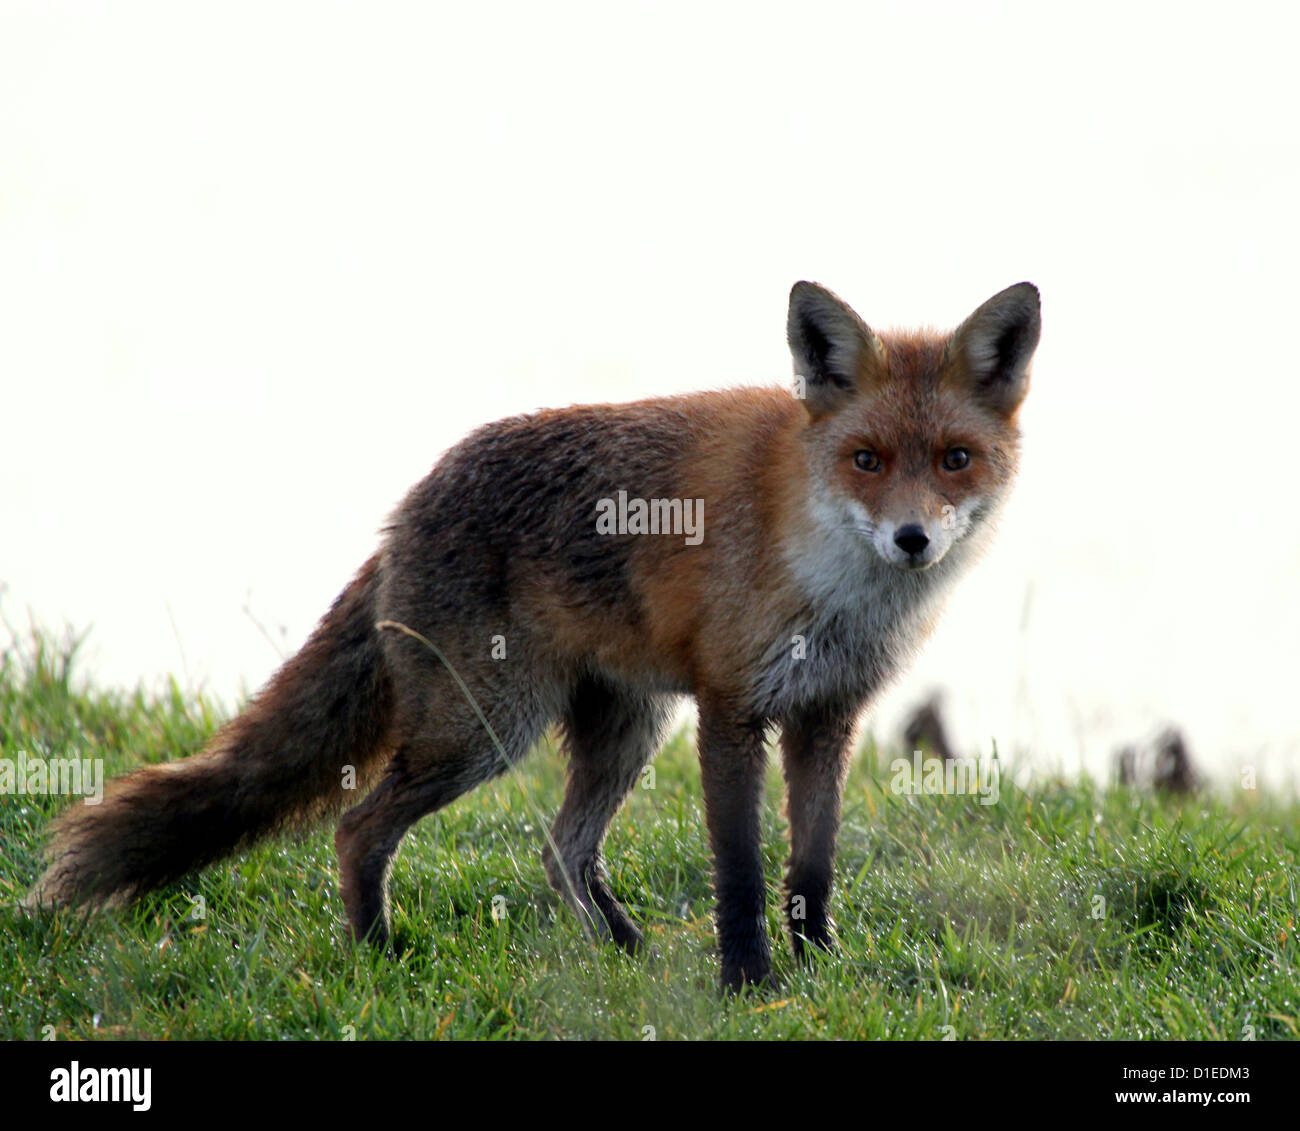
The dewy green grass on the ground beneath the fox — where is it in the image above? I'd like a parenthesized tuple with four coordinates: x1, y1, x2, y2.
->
(0, 634, 1300, 1040)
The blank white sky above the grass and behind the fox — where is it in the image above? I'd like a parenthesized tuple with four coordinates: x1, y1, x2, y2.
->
(0, 0, 1300, 788)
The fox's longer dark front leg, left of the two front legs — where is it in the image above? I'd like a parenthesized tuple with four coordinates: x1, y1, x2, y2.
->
(699, 702, 772, 991)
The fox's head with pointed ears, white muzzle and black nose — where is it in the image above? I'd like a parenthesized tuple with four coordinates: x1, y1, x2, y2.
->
(788, 282, 1040, 569)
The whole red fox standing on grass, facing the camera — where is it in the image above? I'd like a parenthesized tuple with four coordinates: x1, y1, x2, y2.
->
(27, 282, 1040, 989)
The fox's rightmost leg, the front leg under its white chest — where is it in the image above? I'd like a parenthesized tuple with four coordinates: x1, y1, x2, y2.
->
(781, 710, 854, 957)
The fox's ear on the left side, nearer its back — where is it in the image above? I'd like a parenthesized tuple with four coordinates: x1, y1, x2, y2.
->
(785, 282, 883, 416)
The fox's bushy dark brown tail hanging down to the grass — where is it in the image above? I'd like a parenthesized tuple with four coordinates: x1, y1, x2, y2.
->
(25, 555, 391, 906)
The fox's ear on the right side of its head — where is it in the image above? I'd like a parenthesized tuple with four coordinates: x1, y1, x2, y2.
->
(948, 283, 1043, 416)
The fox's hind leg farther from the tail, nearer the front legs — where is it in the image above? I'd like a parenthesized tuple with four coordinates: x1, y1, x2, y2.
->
(543, 677, 673, 953)
